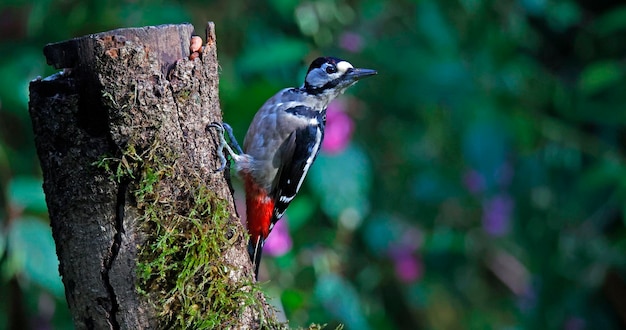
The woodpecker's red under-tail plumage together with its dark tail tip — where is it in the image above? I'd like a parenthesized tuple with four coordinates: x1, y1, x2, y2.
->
(243, 174, 274, 278)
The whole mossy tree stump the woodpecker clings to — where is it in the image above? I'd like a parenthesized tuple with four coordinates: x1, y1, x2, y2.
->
(29, 23, 274, 329)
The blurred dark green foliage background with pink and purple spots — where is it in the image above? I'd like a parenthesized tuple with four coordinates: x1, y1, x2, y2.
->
(0, 0, 626, 330)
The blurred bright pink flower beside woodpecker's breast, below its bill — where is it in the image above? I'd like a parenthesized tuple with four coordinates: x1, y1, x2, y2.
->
(322, 101, 354, 154)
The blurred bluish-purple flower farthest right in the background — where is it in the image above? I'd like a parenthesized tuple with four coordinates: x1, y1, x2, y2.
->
(483, 194, 514, 236)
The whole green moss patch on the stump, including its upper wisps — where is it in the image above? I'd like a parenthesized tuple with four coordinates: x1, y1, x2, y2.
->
(95, 141, 266, 329)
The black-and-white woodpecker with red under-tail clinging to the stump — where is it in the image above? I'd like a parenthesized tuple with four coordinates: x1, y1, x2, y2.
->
(209, 57, 377, 277)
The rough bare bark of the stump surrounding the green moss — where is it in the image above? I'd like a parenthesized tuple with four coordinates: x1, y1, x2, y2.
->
(29, 23, 267, 329)
